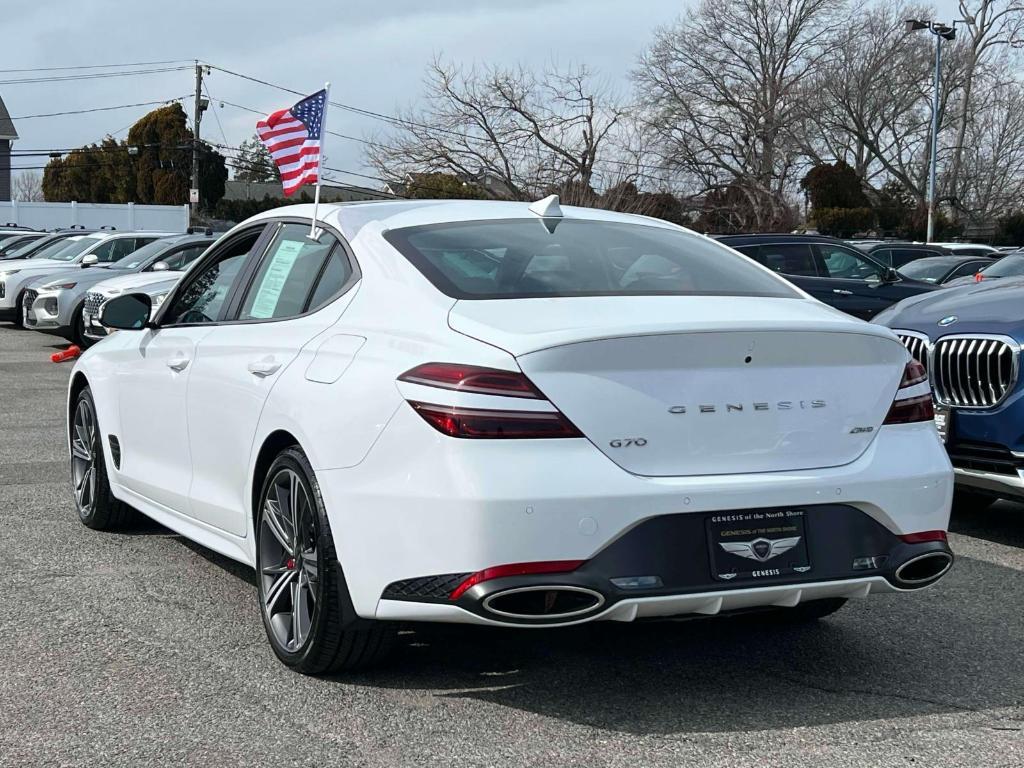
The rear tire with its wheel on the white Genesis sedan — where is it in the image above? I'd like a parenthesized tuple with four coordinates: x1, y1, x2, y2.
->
(256, 447, 395, 675)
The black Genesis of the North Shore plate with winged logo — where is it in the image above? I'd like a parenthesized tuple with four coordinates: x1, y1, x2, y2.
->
(705, 509, 812, 583)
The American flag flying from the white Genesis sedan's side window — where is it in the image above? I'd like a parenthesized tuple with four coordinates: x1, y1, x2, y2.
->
(256, 89, 327, 197)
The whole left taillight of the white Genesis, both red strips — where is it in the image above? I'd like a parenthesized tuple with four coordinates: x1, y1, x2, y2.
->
(398, 362, 583, 439)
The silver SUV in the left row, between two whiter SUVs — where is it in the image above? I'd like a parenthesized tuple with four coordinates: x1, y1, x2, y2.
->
(23, 234, 214, 345)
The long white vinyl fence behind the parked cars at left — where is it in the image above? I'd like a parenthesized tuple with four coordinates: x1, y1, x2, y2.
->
(0, 201, 188, 232)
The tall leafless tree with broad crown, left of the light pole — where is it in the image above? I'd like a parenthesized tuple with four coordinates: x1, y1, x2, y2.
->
(635, 0, 842, 228)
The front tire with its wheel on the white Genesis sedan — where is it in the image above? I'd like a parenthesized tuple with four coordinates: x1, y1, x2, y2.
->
(68, 387, 135, 530)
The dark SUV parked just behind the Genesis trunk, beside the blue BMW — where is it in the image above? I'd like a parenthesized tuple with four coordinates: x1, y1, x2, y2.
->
(718, 234, 936, 319)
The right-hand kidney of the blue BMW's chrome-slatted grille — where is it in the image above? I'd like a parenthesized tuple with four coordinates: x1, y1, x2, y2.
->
(933, 335, 1020, 409)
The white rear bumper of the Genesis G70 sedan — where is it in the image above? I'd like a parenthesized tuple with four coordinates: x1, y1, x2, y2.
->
(312, 408, 953, 624)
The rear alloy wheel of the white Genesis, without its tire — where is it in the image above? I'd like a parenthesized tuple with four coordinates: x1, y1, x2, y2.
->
(259, 468, 319, 653)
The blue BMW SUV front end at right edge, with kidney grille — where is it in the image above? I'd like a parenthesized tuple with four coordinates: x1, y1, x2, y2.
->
(874, 279, 1024, 508)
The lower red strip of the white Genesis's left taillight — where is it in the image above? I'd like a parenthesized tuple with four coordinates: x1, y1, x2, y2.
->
(409, 400, 583, 439)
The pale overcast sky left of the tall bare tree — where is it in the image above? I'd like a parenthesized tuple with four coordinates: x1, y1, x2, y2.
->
(0, 0, 686, 184)
